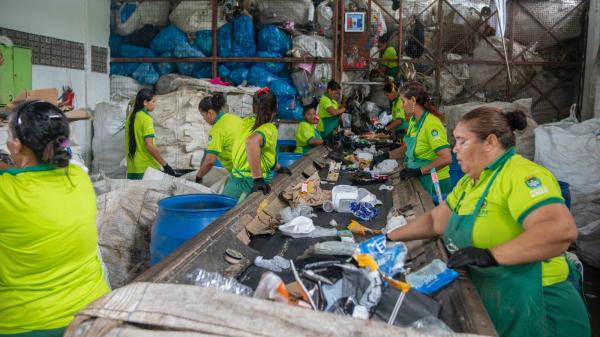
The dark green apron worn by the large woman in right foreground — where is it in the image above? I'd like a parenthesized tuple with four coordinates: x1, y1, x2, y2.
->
(443, 158, 547, 337)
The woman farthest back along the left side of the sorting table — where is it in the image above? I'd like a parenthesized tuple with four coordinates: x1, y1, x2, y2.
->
(317, 80, 346, 139)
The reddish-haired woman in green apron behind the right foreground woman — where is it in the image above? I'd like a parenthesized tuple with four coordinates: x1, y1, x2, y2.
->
(375, 82, 452, 195)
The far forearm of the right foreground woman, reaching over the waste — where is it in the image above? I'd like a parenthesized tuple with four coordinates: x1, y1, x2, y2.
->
(387, 202, 451, 241)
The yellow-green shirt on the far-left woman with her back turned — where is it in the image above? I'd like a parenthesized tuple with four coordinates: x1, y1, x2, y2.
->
(0, 164, 110, 334)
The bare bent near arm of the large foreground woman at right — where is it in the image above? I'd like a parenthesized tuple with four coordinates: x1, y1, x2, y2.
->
(491, 203, 577, 265)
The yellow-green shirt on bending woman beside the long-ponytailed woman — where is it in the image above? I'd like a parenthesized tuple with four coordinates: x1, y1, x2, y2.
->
(206, 111, 242, 172)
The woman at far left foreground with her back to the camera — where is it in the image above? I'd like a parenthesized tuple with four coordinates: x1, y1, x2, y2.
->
(0, 101, 110, 337)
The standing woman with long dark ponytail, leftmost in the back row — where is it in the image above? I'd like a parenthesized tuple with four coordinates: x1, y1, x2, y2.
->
(125, 88, 175, 180)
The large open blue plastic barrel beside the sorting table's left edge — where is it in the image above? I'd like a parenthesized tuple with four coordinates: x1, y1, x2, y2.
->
(150, 194, 237, 265)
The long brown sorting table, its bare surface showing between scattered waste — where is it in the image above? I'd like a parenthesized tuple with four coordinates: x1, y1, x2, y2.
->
(136, 146, 497, 336)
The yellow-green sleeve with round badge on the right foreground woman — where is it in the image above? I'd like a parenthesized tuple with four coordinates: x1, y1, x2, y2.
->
(508, 164, 565, 224)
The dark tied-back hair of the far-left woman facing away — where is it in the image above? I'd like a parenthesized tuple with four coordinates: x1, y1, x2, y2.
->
(10, 101, 71, 167)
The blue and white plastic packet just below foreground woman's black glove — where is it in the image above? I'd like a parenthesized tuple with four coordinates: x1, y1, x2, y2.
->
(406, 259, 458, 295)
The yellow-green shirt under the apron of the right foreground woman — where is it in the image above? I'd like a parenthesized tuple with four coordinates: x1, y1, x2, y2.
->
(446, 148, 569, 286)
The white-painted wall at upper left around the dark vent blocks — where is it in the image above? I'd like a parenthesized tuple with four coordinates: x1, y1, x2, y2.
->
(0, 0, 110, 162)
